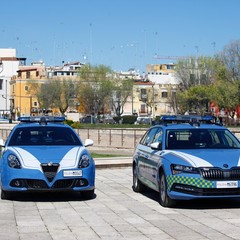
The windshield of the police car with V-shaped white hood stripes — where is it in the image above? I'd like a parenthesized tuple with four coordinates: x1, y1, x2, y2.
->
(8, 126, 82, 146)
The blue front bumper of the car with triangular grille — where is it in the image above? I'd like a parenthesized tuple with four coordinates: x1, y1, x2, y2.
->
(1, 167, 95, 192)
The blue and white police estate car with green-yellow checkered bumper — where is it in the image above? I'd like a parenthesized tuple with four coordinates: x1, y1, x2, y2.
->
(133, 116, 240, 207)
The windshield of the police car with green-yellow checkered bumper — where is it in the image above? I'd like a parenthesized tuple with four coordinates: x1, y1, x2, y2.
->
(166, 129, 240, 149)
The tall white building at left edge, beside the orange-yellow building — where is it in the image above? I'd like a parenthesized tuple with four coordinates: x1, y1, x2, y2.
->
(0, 48, 26, 117)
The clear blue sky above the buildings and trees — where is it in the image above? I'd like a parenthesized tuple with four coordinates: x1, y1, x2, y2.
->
(0, 0, 240, 74)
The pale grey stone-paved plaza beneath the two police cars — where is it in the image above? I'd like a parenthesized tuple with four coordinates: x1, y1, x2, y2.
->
(0, 167, 240, 240)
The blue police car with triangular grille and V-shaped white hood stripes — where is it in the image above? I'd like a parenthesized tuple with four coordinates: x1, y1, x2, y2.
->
(0, 116, 95, 199)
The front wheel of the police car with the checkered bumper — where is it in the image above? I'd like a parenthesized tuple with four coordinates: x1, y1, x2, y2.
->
(159, 171, 176, 207)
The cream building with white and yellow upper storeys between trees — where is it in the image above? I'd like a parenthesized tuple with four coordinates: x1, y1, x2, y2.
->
(124, 63, 178, 118)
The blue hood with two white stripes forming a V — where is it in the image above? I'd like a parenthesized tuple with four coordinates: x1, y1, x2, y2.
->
(6, 146, 85, 168)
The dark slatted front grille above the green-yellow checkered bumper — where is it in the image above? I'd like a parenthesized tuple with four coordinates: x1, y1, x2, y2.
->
(199, 168, 240, 181)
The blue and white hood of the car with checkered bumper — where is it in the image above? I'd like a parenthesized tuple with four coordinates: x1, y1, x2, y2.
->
(162, 149, 240, 168)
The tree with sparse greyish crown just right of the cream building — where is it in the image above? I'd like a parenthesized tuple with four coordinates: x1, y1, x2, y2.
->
(176, 55, 229, 114)
